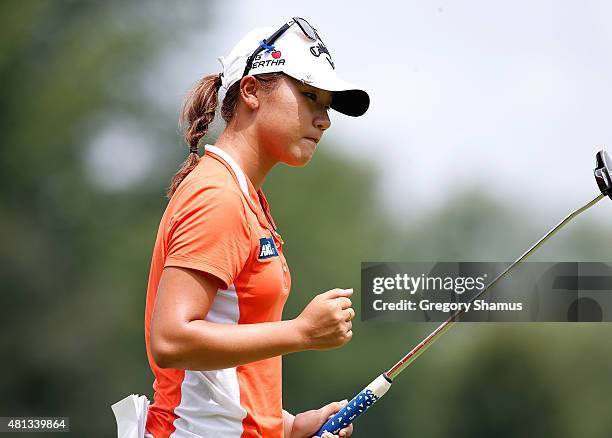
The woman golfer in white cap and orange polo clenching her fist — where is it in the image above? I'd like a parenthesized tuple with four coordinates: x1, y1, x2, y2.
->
(145, 18, 369, 438)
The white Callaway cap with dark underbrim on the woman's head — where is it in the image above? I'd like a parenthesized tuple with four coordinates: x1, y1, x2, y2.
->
(219, 24, 370, 117)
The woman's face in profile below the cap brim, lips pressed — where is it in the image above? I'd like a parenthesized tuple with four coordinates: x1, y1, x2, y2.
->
(257, 75, 332, 166)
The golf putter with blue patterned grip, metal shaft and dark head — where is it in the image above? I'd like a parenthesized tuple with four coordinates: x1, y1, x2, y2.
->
(316, 150, 612, 437)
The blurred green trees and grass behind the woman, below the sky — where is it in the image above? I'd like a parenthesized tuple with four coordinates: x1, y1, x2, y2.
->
(0, 0, 612, 437)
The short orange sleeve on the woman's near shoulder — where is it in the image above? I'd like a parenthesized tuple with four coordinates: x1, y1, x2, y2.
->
(164, 184, 251, 288)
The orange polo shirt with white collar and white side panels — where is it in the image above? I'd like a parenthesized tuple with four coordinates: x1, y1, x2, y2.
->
(145, 145, 291, 438)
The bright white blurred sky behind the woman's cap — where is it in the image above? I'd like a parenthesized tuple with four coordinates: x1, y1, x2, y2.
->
(87, 0, 612, 222)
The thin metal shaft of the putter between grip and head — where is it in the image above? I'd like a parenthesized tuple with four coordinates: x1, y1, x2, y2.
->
(385, 194, 605, 380)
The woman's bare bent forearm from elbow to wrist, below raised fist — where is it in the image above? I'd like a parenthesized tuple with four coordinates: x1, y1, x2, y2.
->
(156, 320, 304, 371)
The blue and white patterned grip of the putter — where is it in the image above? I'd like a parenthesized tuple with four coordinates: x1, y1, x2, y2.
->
(316, 374, 391, 437)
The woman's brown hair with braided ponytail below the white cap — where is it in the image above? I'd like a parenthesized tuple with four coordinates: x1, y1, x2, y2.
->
(166, 73, 283, 198)
